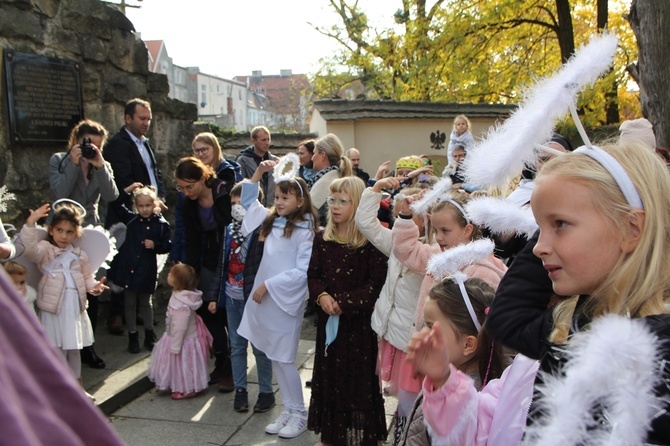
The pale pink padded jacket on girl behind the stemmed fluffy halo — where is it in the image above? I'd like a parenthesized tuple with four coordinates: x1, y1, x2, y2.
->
(393, 218, 507, 330)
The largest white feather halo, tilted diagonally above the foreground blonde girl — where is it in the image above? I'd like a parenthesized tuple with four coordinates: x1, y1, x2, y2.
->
(463, 33, 617, 188)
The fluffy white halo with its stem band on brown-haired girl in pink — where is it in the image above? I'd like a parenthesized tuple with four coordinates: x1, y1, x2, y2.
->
(426, 239, 495, 332)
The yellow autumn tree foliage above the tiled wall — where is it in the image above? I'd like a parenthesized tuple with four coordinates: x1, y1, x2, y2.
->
(315, 0, 635, 125)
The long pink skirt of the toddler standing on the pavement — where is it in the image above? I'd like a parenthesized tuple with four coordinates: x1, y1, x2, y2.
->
(147, 316, 212, 393)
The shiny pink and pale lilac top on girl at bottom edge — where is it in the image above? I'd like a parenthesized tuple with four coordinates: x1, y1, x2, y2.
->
(422, 354, 539, 446)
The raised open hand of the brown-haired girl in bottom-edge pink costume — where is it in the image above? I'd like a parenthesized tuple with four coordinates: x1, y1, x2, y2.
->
(406, 322, 450, 388)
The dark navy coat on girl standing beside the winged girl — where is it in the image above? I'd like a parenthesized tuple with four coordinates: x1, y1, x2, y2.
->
(109, 204, 171, 293)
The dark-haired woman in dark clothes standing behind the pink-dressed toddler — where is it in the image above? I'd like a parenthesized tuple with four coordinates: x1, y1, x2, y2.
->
(175, 157, 235, 392)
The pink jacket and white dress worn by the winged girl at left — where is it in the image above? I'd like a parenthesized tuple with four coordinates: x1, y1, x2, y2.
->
(21, 225, 97, 350)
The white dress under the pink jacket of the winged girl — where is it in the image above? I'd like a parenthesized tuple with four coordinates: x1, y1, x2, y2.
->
(40, 249, 93, 350)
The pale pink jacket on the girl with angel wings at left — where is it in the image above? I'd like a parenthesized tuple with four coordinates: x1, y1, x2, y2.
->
(21, 225, 97, 314)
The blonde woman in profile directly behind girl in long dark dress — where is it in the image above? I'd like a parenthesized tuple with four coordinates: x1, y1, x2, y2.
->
(307, 133, 353, 226)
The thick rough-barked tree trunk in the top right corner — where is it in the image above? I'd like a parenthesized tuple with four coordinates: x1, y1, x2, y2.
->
(628, 0, 670, 147)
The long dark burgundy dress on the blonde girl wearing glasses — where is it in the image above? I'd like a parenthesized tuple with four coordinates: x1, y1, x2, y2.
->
(307, 232, 388, 446)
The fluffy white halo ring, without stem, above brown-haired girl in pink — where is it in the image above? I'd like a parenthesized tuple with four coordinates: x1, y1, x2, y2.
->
(426, 238, 495, 281)
